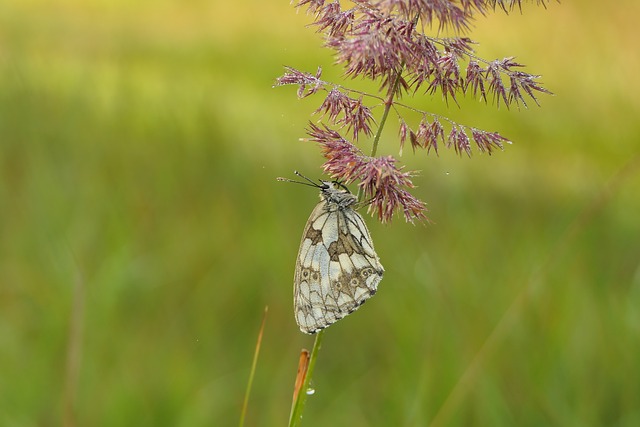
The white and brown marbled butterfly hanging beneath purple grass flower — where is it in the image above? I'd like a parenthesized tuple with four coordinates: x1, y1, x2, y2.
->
(280, 172, 384, 334)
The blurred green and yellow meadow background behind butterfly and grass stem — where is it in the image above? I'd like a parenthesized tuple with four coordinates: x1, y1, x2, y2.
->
(0, 0, 640, 427)
